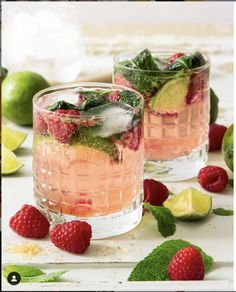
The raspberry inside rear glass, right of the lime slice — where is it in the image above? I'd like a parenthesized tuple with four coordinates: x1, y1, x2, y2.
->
(186, 71, 208, 104)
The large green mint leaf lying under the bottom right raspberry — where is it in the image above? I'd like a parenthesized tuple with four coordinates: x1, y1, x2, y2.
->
(128, 239, 213, 281)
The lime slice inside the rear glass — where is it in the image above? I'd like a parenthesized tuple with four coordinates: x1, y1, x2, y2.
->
(149, 77, 190, 113)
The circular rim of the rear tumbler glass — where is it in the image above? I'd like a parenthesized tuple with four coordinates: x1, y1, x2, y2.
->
(113, 49, 211, 77)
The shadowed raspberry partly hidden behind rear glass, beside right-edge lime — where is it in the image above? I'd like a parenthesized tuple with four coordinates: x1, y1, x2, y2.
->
(209, 124, 227, 151)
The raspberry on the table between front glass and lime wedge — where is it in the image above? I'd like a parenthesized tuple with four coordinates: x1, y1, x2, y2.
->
(143, 179, 169, 206)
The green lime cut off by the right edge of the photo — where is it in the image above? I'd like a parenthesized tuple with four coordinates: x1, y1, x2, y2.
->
(222, 125, 234, 171)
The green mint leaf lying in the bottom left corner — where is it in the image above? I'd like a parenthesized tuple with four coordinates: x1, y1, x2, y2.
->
(3, 265, 44, 279)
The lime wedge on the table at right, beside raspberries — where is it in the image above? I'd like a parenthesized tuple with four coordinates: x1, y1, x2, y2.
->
(163, 188, 212, 221)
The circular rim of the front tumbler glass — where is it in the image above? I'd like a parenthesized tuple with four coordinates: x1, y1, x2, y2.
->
(32, 82, 144, 119)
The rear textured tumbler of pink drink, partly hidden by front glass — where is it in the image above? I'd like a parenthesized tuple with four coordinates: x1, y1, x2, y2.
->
(113, 51, 210, 181)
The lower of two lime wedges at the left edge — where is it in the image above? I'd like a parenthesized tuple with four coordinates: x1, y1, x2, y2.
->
(2, 144, 23, 174)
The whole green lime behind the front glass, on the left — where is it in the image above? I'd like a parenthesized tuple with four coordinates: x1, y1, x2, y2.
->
(2, 72, 50, 126)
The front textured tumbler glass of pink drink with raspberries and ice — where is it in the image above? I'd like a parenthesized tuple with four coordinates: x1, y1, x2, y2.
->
(33, 82, 144, 238)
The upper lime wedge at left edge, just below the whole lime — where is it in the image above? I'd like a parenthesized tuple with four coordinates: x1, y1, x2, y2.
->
(2, 126, 27, 151)
